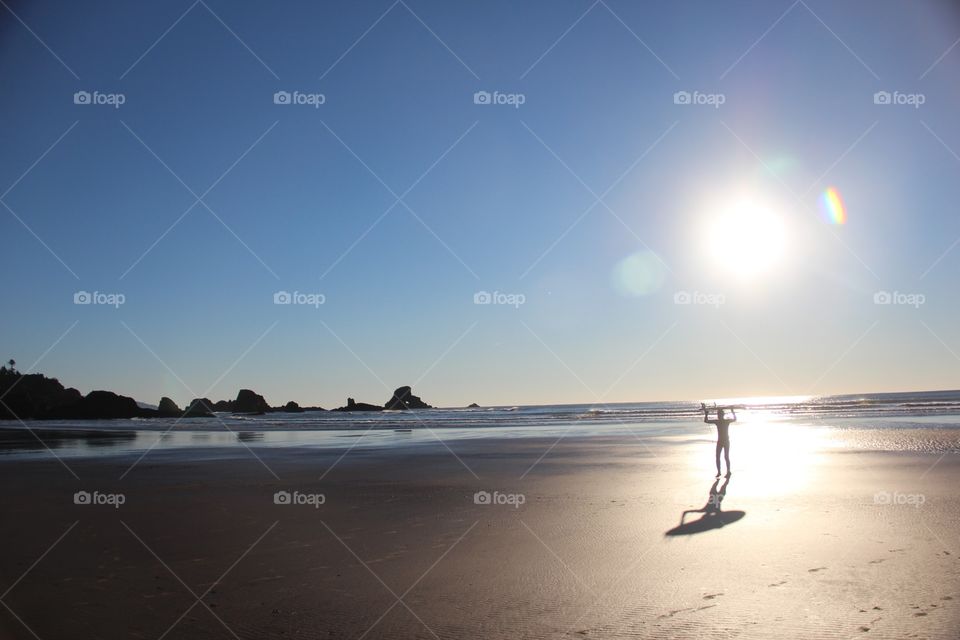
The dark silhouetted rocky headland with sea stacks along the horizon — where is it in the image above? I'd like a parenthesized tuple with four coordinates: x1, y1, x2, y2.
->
(0, 360, 433, 420)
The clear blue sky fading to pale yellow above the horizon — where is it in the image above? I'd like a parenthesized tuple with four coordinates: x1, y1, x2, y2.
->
(0, 0, 960, 408)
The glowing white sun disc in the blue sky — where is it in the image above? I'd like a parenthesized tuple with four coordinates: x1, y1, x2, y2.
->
(704, 200, 786, 280)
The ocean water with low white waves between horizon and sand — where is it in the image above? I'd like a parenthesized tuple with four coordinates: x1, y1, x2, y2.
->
(0, 391, 960, 459)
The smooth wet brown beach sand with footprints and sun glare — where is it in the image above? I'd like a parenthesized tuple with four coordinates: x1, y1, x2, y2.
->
(0, 435, 960, 640)
